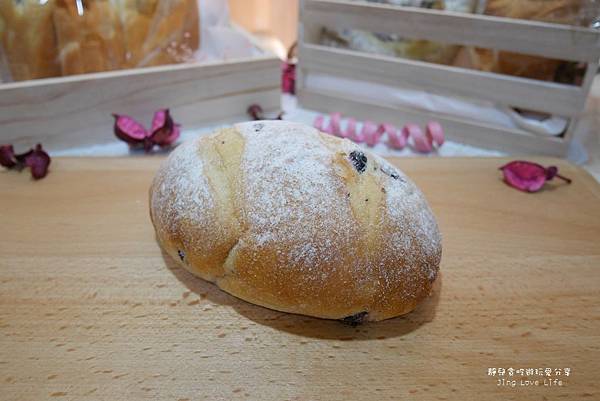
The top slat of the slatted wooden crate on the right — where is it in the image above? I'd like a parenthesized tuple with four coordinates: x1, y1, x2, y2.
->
(302, 0, 600, 62)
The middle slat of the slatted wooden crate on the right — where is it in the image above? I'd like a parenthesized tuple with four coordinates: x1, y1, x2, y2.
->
(300, 44, 585, 116)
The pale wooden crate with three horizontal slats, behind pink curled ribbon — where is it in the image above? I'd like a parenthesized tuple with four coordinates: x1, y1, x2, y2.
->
(297, 0, 600, 156)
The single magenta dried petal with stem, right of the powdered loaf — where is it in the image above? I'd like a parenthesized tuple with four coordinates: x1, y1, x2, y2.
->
(500, 160, 571, 192)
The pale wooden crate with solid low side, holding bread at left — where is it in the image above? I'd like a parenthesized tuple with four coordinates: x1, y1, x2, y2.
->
(0, 27, 281, 150)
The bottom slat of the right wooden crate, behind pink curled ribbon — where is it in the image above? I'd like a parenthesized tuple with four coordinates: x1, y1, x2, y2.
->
(298, 88, 567, 157)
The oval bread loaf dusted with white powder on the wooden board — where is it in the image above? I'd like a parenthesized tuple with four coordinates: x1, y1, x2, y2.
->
(150, 121, 441, 322)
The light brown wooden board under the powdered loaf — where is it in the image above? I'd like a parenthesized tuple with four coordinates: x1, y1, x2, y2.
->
(0, 157, 600, 400)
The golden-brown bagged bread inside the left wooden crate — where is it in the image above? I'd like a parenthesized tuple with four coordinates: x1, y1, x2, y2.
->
(0, 0, 200, 81)
